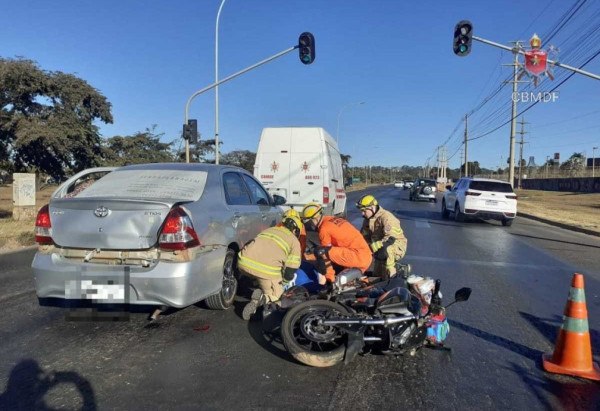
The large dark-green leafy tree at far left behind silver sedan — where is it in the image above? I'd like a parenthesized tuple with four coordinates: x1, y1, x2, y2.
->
(0, 58, 113, 179)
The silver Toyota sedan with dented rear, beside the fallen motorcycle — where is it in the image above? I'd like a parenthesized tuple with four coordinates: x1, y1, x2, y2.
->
(32, 163, 285, 309)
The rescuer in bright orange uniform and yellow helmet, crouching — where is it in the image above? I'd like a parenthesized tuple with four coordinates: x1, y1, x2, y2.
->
(302, 203, 372, 284)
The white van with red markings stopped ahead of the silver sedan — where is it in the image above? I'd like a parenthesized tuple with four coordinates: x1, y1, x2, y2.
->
(254, 127, 346, 216)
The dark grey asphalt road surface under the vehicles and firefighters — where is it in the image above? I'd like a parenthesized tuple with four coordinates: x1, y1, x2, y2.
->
(0, 186, 600, 410)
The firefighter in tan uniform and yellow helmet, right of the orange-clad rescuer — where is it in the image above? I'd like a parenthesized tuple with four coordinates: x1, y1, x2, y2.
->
(356, 194, 408, 279)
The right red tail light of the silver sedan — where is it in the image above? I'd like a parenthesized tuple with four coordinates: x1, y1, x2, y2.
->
(158, 207, 200, 250)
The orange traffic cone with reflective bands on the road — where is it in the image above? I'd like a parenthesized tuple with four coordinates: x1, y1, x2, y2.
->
(542, 273, 600, 381)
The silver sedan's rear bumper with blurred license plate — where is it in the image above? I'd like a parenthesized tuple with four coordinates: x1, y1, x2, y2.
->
(32, 248, 226, 308)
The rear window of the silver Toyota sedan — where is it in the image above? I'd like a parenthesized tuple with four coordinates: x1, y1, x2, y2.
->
(77, 170, 207, 201)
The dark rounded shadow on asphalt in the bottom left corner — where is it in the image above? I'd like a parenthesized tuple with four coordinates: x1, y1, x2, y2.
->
(0, 359, 97, 411)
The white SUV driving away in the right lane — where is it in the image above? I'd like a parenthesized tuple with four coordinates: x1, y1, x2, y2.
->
(442, 177, 517, 226)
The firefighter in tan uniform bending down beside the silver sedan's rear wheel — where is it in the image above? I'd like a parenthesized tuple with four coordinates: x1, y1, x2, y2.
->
(238, 217, 303, 321)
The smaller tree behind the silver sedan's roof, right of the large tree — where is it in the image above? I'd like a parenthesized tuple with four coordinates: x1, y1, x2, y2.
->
(102, 125, 175, 166)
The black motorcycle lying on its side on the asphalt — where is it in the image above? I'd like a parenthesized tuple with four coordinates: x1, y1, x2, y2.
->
(281, 269, 471, 367)
